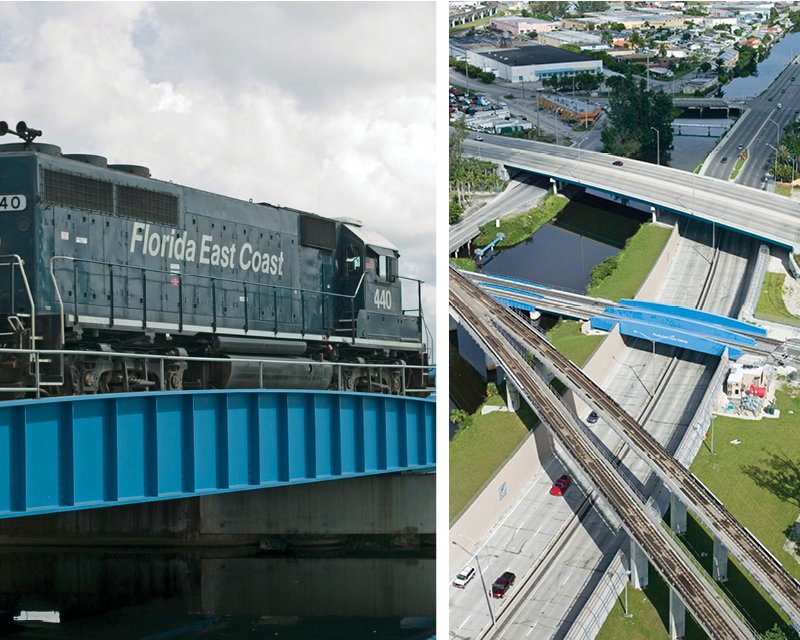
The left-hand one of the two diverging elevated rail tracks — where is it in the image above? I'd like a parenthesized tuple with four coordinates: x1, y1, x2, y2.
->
(450, 269, 753, 640)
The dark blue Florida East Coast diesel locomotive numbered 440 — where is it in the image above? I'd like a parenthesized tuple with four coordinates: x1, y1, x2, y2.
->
(0, 122, 428, 397)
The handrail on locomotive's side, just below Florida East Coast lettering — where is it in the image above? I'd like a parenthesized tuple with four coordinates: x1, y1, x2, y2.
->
(49, 256, 396, 346)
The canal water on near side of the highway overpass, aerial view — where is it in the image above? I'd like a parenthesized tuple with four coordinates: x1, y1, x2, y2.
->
(450, 193, 649, 416)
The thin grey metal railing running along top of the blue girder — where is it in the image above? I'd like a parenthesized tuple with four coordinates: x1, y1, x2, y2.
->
(0, 347, 431, 397)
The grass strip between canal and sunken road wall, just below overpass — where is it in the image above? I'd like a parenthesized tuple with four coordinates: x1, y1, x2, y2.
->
(589, 223, 672, 302)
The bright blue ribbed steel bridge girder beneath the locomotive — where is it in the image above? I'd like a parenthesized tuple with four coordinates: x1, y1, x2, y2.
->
(0, 390, 436, 518)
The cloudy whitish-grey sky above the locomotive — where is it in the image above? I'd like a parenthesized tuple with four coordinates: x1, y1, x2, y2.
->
(0, 2, 436, 344)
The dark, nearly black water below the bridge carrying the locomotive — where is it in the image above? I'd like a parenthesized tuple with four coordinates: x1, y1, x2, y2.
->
(0, 547, 435, 640)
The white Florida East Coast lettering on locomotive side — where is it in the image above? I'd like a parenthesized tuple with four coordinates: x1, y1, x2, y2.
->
(130, 222, 283, 276)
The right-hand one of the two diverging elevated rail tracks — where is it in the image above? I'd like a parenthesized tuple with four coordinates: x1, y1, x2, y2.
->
(462, 270, 800, 623)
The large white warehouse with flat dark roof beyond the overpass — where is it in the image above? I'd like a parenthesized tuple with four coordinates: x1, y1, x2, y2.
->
(450, 45, 603, 82)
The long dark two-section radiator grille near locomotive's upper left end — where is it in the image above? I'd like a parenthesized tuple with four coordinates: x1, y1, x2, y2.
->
(42, 169, 178, 226)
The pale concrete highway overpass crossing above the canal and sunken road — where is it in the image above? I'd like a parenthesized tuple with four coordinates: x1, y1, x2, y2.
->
(464, 135, 800, 248)
